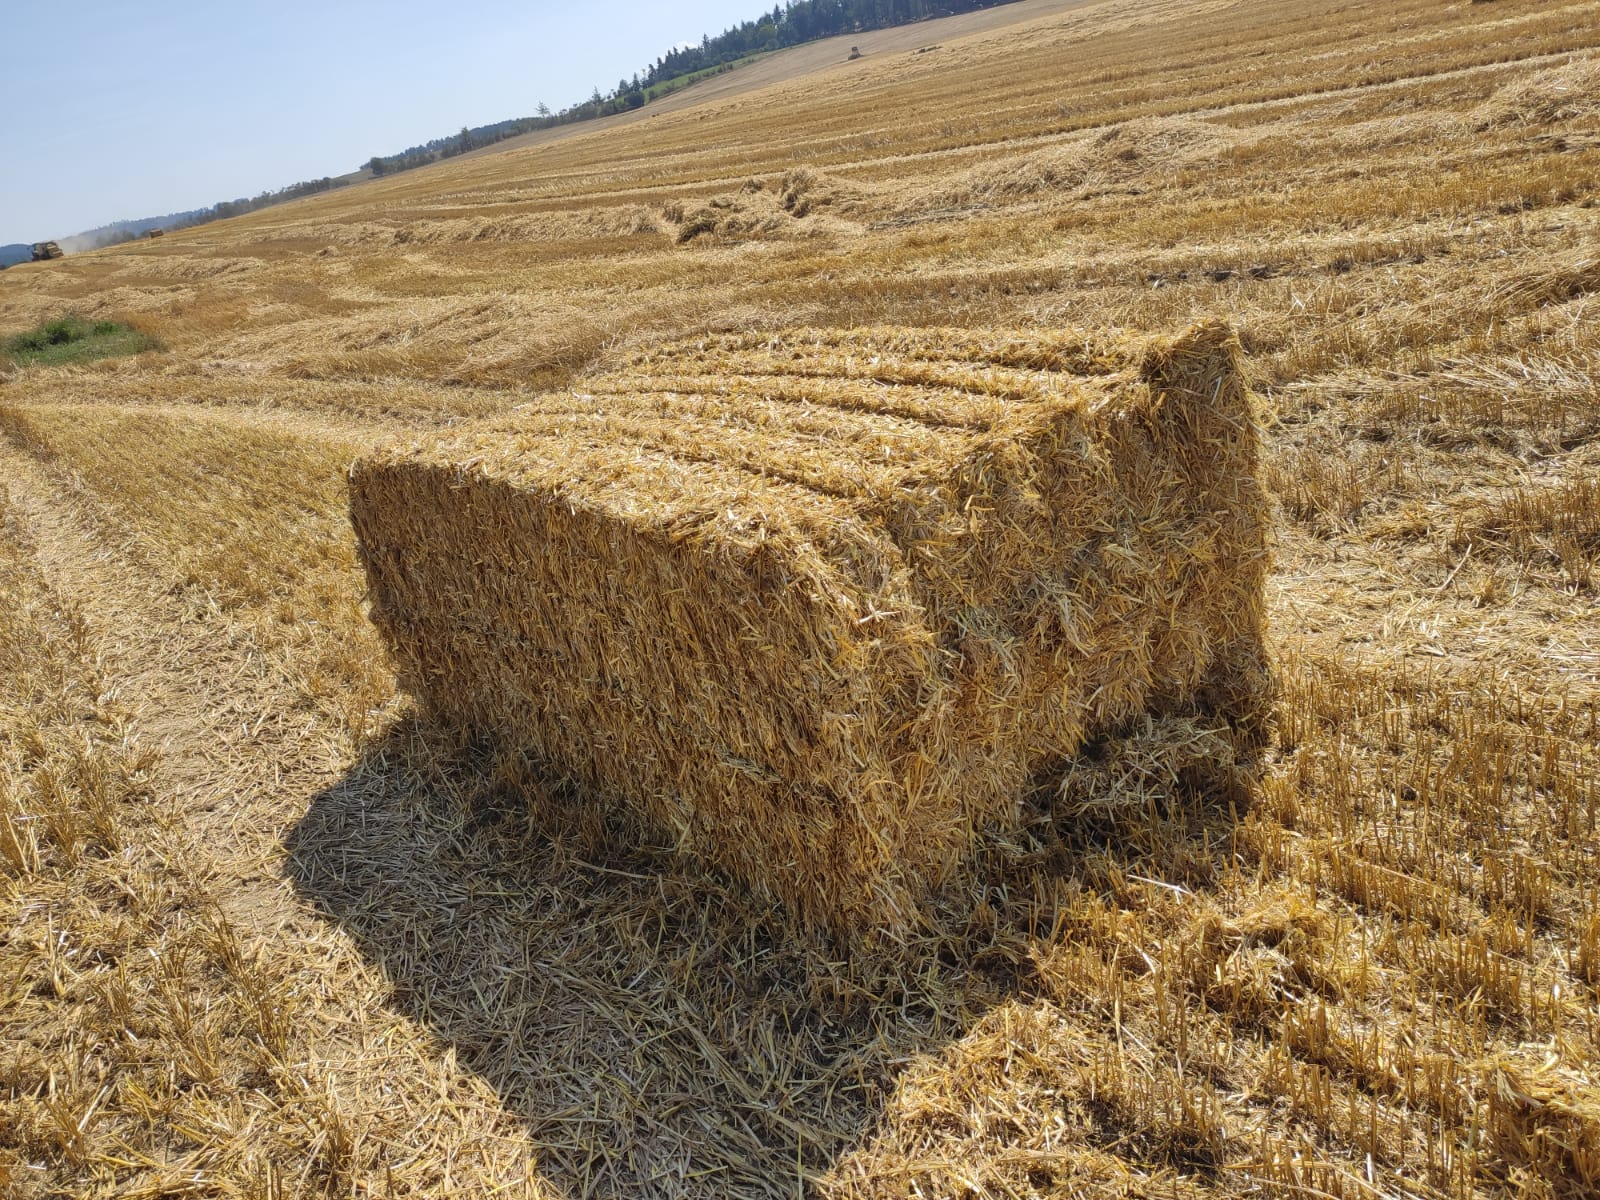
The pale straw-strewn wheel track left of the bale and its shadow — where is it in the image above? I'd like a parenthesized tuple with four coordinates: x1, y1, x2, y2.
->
(0, 422, 554, 1200)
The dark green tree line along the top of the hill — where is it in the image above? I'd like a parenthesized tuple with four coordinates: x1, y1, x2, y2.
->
(362, 0, 1014, 176)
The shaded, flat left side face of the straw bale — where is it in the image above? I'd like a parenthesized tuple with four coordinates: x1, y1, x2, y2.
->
(352, 451, 958, 922)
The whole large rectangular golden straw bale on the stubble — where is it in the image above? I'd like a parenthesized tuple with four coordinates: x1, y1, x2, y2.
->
(350, 323, 1266, 934)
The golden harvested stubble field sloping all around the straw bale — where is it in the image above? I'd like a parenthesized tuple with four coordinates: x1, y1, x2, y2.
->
(0, 0, 1600, 1200)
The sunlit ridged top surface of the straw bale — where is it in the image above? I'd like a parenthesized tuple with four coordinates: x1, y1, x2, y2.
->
(368, 330, 1139, 544)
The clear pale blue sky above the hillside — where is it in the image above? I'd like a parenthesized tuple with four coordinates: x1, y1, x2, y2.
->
(0, 0, 773, 243)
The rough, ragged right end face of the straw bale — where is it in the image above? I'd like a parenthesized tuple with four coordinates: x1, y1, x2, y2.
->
(888, 325, 1269, 822)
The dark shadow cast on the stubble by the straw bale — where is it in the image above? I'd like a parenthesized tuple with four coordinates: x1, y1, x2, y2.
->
(286, 722, 1227, 1197)
